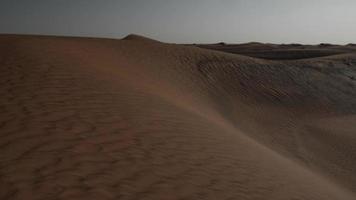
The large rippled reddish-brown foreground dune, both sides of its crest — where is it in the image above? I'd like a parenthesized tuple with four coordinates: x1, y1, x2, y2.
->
(0, 35, 356, 200)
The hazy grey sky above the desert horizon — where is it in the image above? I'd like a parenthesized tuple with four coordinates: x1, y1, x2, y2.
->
(0, 0, 356, 44)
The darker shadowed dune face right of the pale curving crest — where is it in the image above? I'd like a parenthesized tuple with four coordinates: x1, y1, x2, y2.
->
(188, 51, 356, 191)
